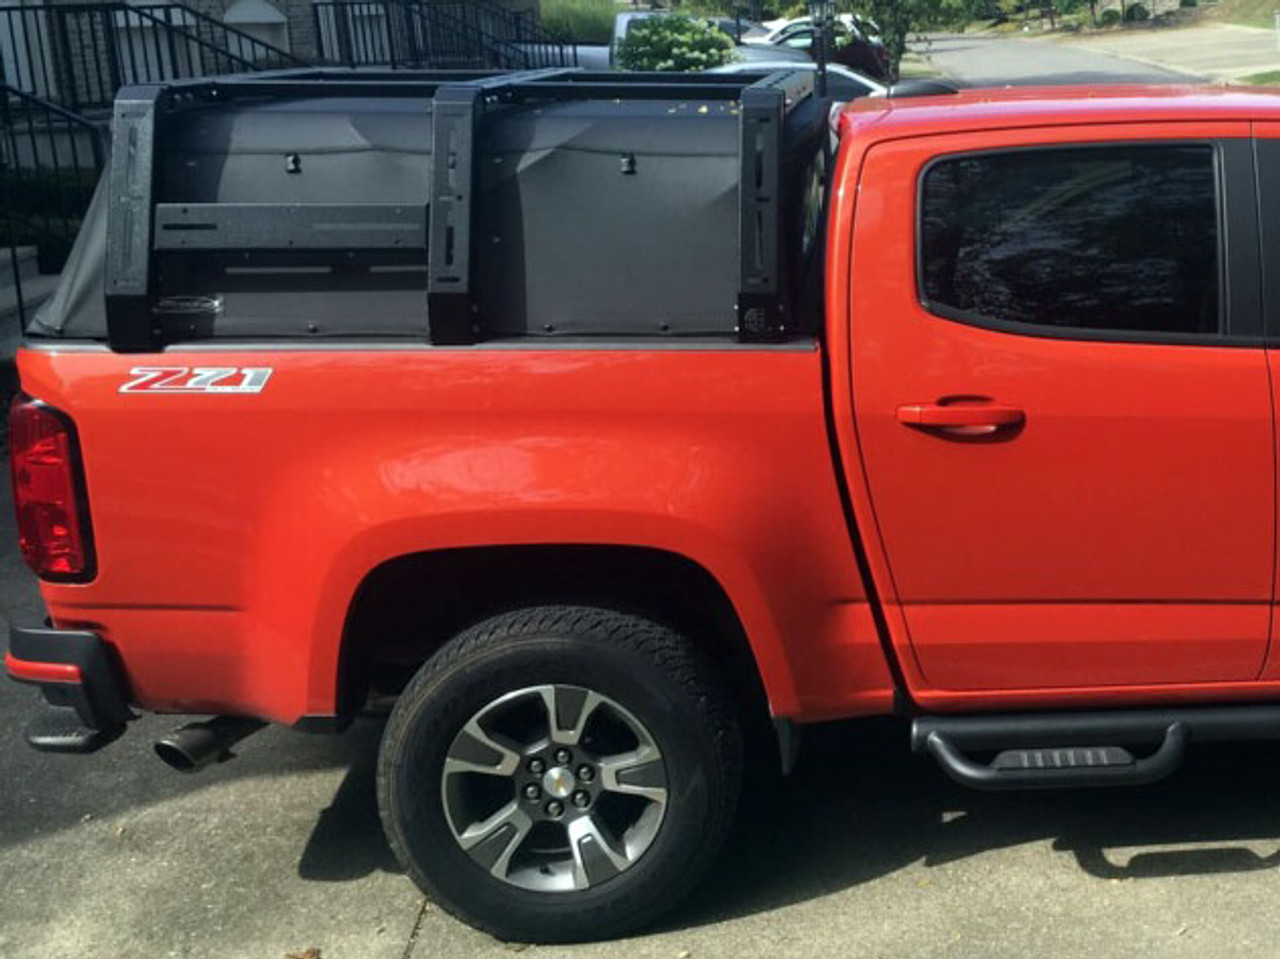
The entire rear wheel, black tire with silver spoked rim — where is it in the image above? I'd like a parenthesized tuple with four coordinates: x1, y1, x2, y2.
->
(378, 606, 742, 942)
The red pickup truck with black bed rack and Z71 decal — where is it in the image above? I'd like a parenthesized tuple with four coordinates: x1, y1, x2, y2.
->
(5, 72, 1280, 940)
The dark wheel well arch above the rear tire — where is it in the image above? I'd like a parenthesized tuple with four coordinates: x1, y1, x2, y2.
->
(338, 545, 768, 726)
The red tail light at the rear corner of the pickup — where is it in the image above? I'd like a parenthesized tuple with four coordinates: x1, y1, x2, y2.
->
(9, 396, 95, 583)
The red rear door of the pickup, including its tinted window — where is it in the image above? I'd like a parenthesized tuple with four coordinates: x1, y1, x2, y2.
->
(850, 123, 1276, 690)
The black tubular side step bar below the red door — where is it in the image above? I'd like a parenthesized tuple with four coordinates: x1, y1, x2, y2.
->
(911, 705, 1280, 790)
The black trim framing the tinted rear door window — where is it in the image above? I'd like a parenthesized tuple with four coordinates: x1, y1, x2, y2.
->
(914, 137, 1265, 347)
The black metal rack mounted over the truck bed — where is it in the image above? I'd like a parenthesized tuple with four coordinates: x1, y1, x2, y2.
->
(104, 68, 826, 352)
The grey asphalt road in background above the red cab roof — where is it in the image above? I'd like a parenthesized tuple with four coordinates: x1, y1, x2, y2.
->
(913, 33, 1198, 86)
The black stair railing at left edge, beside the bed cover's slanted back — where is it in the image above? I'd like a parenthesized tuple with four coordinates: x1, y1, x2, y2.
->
(0, 83, 106, 323)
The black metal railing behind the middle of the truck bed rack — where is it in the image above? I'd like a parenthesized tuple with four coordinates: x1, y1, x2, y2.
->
(312, 0, 577, 69)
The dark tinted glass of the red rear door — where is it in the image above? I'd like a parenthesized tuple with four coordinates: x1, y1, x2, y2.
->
(922, 145, 1220, 333)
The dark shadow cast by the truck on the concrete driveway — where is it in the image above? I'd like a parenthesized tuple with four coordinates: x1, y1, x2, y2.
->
(282, 721, 1280, 928)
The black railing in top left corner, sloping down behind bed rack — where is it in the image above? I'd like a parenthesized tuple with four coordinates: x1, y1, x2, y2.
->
(0, 3, 305, 111)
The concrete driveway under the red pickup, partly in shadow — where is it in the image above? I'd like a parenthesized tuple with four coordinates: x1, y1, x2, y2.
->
(10, 471, 1280, 959)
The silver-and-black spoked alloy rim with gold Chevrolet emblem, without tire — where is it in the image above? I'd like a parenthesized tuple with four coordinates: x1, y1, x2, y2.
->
(439, 682, 668, 892)
